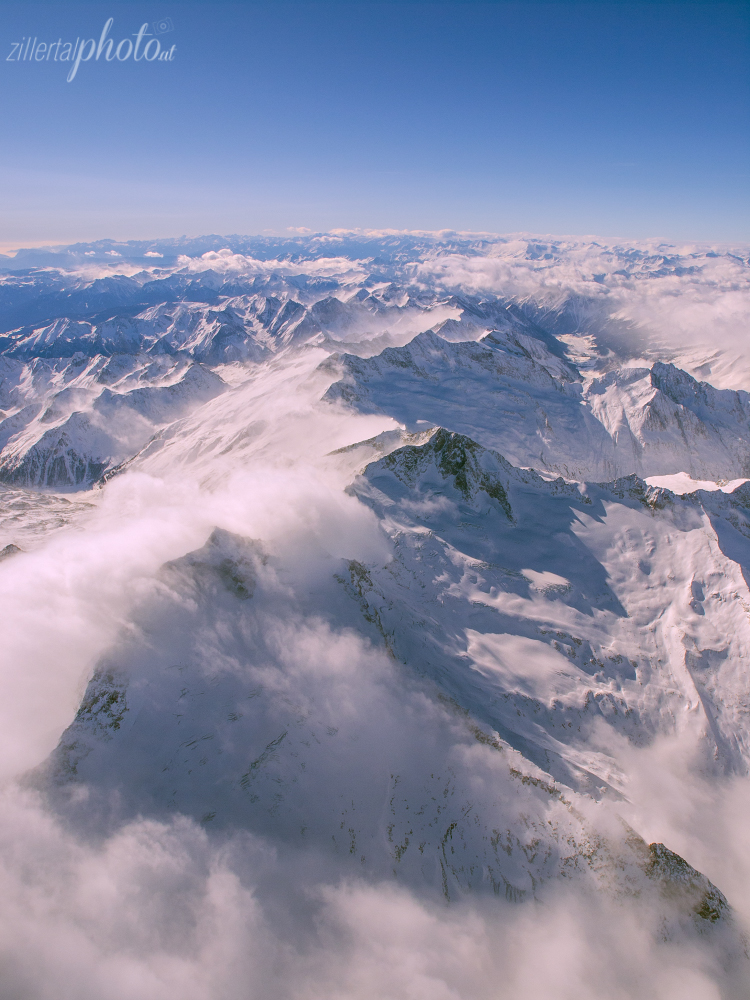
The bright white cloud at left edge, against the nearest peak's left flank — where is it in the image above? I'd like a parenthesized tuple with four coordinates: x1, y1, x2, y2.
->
(0, 476, 212, 777)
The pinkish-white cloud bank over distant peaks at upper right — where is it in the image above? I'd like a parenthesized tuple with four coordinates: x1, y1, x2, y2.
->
(415, 237, 750, 389)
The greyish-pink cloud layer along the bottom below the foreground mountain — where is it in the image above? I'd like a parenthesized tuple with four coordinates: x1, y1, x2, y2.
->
(0, 788, 745, 1000)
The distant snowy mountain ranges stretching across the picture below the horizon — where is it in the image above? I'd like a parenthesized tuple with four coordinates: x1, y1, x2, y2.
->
(0, 234, 750, 489)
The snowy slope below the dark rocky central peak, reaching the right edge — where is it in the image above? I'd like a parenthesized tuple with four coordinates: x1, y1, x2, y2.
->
(352, 430, 750, 794)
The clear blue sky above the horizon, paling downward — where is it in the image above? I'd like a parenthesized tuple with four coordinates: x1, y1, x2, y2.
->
(0, 0, 750, 248)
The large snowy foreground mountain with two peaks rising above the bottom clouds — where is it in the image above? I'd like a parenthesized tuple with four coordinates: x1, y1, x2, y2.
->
(38, 429, 750, 880)
